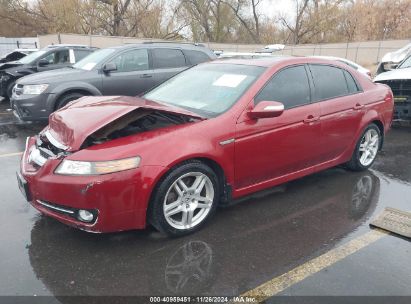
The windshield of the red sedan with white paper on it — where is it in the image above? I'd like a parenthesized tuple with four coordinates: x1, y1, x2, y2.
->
(143, 64, 265, 117)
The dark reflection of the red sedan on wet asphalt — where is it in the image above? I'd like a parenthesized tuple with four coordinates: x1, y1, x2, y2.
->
(28, 170, 380, 295)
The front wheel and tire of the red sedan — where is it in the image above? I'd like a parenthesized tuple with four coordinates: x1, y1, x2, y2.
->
(148, 160, 220, 237)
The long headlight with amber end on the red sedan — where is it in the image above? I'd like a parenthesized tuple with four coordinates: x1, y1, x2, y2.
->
(55, 156, 141, 175)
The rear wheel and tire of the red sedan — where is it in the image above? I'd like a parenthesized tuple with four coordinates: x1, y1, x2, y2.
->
(347, 124, 382, 171)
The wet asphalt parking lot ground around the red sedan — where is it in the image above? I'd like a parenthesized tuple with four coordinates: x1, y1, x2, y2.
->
(0, 102, 411, 303)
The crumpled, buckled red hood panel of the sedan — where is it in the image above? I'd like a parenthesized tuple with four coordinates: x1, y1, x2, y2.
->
(46, 96, 203, 151)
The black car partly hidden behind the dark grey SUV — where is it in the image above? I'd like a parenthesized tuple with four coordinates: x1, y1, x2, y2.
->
(0, 44, 96, 98)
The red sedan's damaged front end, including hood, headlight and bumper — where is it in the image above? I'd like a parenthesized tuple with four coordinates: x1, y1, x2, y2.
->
(17, 97, 204, 232)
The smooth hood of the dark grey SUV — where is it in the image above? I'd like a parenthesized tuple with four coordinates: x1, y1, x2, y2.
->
(17, 68, 89, 85)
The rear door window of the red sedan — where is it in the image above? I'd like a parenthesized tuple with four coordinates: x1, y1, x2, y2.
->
(310, 64, 349, 101)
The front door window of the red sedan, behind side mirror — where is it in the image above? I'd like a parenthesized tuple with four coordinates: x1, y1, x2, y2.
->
(254, 65, 311, 109)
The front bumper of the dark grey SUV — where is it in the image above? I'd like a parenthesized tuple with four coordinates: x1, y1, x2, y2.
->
(10, 93, 54, 121)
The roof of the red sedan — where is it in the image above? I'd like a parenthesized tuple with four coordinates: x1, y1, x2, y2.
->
(211, 55, 346, 68)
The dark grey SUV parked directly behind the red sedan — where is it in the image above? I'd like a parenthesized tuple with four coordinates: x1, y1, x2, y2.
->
(11, 42, 216, 121)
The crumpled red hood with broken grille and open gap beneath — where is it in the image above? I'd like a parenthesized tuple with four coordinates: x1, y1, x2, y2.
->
(27, 97, 204, 169)
